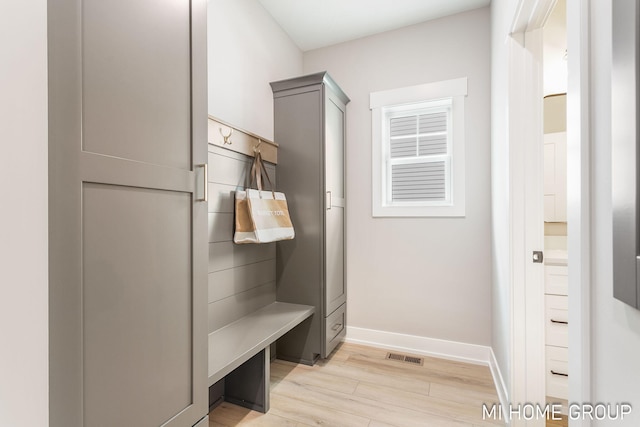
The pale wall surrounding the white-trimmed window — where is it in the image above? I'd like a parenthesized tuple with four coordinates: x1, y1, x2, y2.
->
(304, 8, 491, 345)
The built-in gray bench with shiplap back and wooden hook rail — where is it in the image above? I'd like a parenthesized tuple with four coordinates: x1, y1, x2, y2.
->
(208, 117, 315, 412)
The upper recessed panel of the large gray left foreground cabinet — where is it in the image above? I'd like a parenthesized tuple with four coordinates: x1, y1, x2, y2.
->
(81, 0, 191, 169)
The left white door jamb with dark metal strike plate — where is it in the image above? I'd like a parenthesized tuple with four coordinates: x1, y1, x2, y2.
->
(508, 4, 555, 427)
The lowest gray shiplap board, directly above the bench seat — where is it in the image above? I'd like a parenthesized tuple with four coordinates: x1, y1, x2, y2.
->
(209, 282, 276, 331)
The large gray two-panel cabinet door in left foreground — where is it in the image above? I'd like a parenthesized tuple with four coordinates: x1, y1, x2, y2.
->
(48, 0, 207, 427)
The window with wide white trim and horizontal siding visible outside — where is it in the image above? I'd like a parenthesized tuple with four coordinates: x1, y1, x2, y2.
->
(371, 78, 467, 216)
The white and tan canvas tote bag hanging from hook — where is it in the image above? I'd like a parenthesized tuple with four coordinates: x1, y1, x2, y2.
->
(233, 151, 295, 244)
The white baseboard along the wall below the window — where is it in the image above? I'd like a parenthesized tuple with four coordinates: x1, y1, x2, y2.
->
(345, 326, 491, 365)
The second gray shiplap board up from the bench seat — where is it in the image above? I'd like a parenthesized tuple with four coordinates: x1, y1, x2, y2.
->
(209, 259, 276, 303)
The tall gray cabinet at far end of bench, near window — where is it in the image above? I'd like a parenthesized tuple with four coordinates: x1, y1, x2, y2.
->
(271, 72, 349, 364)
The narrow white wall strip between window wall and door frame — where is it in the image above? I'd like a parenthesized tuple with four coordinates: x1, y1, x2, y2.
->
(491, 0, 518, 400)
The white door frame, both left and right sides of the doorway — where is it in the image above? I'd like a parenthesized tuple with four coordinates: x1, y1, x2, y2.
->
(509, 0, 591, 426)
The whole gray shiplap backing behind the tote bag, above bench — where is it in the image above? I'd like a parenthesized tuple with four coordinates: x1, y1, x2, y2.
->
(208, 144, 276, 338)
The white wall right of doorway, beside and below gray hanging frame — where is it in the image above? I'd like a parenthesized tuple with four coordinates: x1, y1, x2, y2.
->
(591, 0, 640, 426)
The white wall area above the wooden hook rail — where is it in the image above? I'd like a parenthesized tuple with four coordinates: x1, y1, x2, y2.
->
(207, 0, 302, 139)
